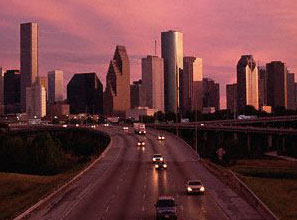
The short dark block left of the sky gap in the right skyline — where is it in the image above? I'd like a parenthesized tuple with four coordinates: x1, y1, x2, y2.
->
(202, 78, 220, 111)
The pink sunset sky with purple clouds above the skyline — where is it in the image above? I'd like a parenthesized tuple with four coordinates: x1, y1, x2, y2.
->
(0, 0, 297, 108)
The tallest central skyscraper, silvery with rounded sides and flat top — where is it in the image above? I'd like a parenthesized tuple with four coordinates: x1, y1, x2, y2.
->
(161, 31, 183, 113)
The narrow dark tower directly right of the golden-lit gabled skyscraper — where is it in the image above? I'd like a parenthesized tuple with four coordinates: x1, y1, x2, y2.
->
(258, 66, 268, 109)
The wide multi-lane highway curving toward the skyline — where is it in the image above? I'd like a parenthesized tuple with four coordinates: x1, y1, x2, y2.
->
(23, 127, 262, 220)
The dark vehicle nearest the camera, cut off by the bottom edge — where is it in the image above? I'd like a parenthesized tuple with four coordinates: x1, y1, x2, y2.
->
(155, 196, 177, 220)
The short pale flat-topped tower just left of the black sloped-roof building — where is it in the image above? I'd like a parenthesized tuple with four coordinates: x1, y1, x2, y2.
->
(47, 70, 64, 103)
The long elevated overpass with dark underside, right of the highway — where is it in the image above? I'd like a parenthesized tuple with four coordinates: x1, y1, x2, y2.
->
(147, 122, 297, 156)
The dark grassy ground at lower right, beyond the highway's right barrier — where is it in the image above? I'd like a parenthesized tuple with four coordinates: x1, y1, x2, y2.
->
(231, 159, 297, 220)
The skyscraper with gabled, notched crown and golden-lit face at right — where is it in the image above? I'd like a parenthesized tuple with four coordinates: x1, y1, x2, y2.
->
(237, 55, 259, 112)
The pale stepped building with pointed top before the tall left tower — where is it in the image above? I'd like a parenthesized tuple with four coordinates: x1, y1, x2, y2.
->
(26, 77, 46, 118)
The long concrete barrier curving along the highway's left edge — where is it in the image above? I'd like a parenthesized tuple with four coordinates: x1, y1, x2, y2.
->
(13, 130, 112, 220)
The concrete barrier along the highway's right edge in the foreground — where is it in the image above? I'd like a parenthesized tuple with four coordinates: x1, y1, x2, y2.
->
(201, 160, 279, 220)
